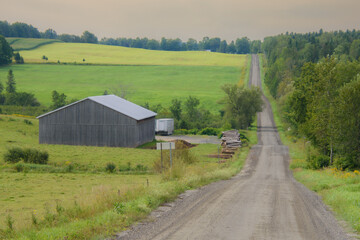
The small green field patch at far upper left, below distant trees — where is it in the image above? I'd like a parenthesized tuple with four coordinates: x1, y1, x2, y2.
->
(6, 38, 60, 51)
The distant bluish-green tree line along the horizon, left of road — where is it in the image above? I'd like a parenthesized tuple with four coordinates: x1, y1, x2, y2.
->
(0, 21, 261, 54)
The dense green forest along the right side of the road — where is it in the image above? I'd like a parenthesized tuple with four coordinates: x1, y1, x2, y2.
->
(262, 30, 360, 169)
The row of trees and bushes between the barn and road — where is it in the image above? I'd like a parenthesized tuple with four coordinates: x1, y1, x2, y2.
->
(143, 84, 263, 135)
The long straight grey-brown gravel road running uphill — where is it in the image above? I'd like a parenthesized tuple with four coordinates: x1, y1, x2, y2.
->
(115, 55, 350, 240)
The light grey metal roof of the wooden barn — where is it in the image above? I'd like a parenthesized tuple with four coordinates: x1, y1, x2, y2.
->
(37, 95, 157, 121)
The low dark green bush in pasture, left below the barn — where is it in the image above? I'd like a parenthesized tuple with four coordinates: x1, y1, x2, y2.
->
(4, 147, 49, 164)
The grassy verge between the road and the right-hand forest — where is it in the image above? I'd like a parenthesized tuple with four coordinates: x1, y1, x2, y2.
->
(260, 55, 360, 233)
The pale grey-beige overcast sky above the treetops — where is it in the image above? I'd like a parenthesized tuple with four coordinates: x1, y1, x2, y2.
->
(0, 0, 360, 40)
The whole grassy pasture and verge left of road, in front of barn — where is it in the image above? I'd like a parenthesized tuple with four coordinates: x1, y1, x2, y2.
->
(0, 115, 256, 239)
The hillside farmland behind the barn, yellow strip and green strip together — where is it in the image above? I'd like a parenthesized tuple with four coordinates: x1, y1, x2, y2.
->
(0, 39, 249, 113)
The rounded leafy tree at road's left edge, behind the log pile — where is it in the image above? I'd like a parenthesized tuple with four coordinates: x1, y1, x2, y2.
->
(222, 84, 263, 129)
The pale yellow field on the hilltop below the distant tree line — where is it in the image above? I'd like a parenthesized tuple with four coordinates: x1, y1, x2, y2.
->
(19, 40, 245, 67)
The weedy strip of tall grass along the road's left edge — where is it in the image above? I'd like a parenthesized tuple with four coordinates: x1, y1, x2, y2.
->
(10, 144, 253, 239)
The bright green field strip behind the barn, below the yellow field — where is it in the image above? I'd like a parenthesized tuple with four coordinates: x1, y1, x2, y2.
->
(0, 63, 246, 112)
